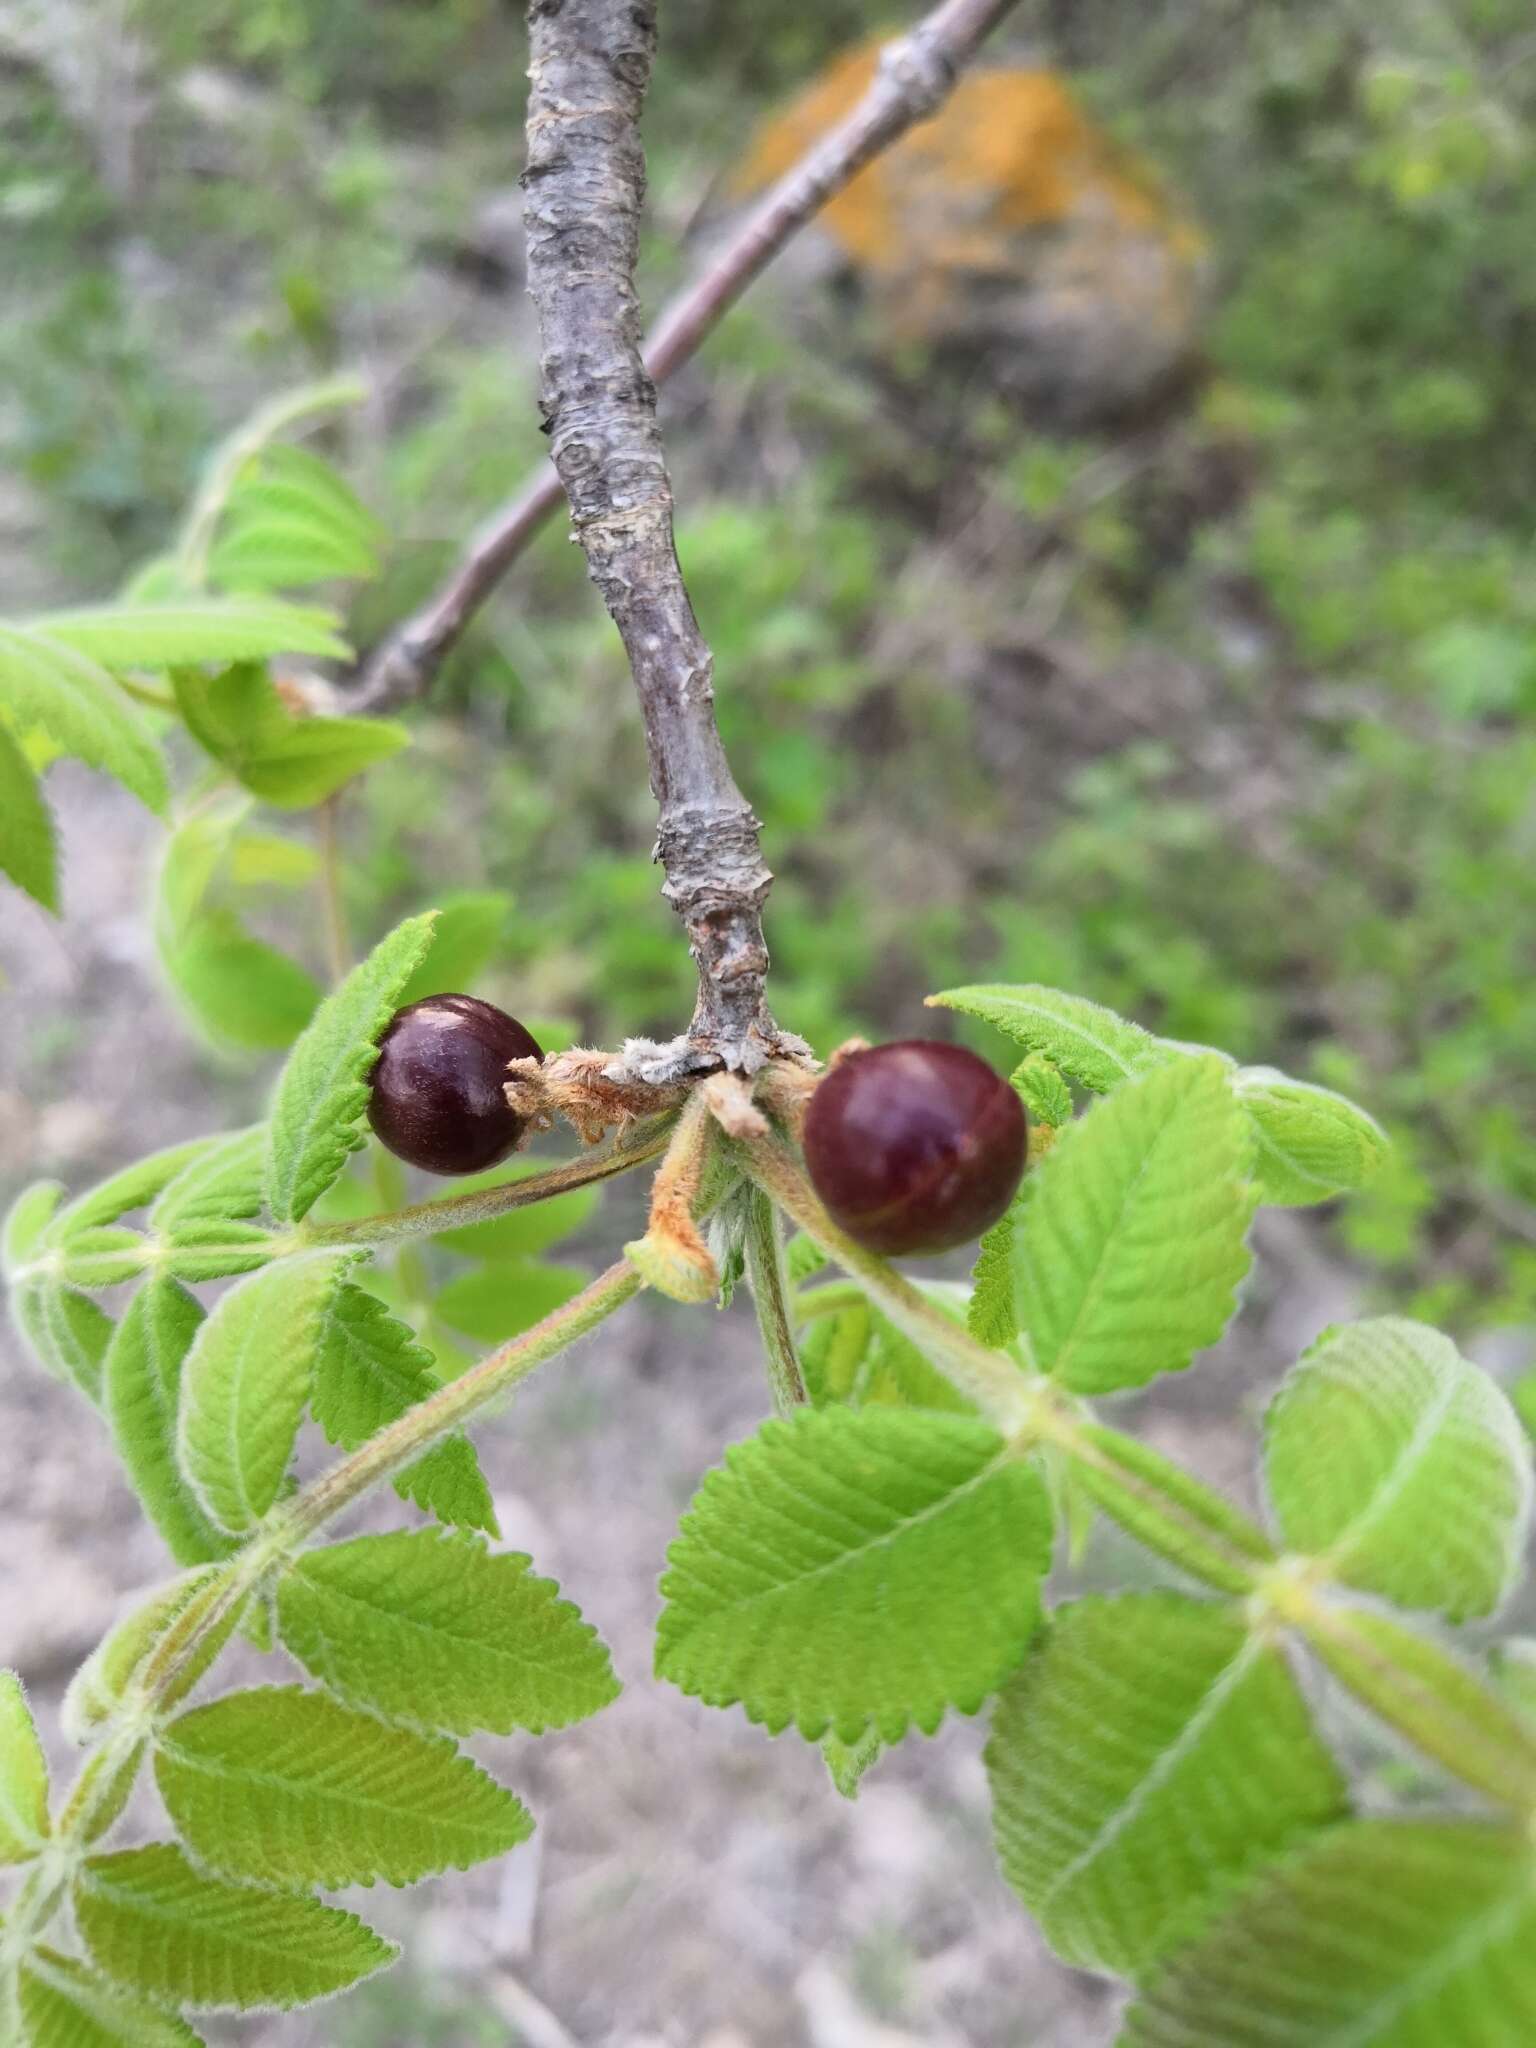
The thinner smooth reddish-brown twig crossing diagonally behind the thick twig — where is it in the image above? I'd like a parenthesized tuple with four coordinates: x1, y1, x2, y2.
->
(350, 0, 1016, 711)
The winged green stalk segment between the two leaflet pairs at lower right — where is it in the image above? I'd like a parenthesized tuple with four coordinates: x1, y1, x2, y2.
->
(1071, 1421, 1274, 1593)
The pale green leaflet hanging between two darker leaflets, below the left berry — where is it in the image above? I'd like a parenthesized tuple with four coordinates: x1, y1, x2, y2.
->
(176, 1251, 356, 1536)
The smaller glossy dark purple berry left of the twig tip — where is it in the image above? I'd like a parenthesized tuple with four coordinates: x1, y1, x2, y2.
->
(369, 995, 545, 1174)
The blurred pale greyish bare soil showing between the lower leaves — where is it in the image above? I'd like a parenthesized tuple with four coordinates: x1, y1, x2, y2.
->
(0, 766, 1354, 2048)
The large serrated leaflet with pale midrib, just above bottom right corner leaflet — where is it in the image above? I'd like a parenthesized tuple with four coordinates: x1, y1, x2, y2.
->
(987, 1593, 1343, 1976)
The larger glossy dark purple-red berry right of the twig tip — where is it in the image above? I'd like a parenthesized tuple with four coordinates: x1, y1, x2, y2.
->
(805, 1038, 1028, 1255)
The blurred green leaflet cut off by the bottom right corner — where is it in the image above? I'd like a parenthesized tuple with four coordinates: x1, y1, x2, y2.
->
(1120, 1821, 1536, 2048)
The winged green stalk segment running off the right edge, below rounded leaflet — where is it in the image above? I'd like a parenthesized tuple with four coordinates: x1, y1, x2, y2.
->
(1305, 1608, 1536, 1812)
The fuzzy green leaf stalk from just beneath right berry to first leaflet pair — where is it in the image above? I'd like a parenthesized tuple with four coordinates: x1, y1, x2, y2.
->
(739, 1137, 1034, 1438)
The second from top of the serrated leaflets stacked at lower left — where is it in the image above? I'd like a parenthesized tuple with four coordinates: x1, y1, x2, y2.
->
(156, 1686, 532, 1888)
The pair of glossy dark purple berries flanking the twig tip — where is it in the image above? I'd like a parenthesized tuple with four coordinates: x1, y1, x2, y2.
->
(369, 995, 1026, 1255)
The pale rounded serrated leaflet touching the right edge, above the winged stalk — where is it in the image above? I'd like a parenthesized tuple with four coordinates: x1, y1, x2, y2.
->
(1264, 1317, 1532, 1622)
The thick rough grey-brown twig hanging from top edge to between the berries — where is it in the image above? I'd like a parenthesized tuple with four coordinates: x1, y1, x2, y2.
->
(522, 0, 786, 1079)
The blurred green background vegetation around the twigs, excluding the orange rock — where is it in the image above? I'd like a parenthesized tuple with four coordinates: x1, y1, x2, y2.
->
(0, 0, 1536, 1333)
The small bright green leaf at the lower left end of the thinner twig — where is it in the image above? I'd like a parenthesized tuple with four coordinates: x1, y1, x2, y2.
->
(174, 662, 410, 809)
